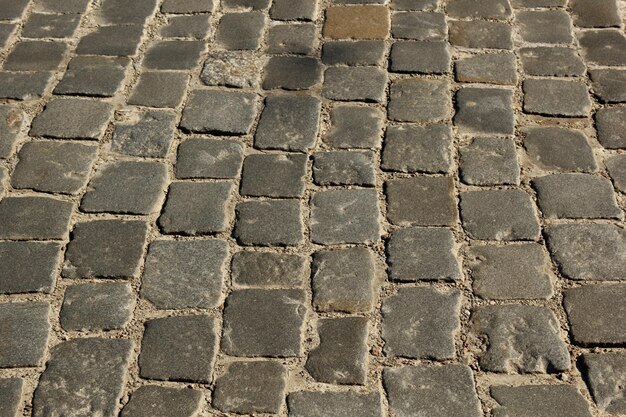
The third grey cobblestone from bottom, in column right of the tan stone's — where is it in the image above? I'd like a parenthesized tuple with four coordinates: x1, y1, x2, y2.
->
(387, 227, 462, 282)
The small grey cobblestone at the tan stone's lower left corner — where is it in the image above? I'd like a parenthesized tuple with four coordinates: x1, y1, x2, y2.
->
(267, 23, 317, 55)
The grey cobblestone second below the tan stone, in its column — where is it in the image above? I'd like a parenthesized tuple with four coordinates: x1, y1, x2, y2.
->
(322, 67, 387, 103)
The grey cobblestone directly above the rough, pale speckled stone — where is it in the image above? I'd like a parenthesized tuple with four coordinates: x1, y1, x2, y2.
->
(215, 11, 265, 50)
